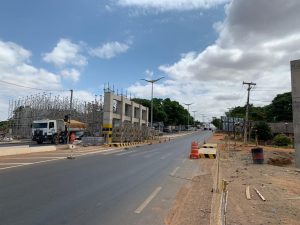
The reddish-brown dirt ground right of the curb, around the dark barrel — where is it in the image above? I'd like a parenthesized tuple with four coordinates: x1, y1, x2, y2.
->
(220, 135, 300, 225)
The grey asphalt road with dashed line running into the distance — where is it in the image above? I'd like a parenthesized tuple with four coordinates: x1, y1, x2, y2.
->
(0, 131, 211, 225)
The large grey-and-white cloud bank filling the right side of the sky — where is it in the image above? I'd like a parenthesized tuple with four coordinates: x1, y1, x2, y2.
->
(130, 0, 300, 119)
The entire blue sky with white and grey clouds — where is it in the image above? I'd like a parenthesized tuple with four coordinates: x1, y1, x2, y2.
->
(0, 0, 300, 121)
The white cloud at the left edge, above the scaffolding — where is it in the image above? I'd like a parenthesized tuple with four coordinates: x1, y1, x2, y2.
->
(0, 41, 62, 120)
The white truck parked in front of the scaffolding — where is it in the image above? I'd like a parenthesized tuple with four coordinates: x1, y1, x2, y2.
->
(31, 119, 67, 144)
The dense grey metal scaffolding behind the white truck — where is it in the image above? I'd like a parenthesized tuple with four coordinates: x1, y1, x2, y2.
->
(8, 93, 103, 138)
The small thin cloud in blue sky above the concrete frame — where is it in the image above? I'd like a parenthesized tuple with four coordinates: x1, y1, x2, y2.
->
(90, 41, 129, 59)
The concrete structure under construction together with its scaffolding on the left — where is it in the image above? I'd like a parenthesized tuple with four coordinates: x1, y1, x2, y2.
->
(9, 87, 155, 142)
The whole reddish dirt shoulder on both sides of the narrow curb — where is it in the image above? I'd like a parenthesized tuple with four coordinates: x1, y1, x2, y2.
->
(165, 134, 300, 225)
